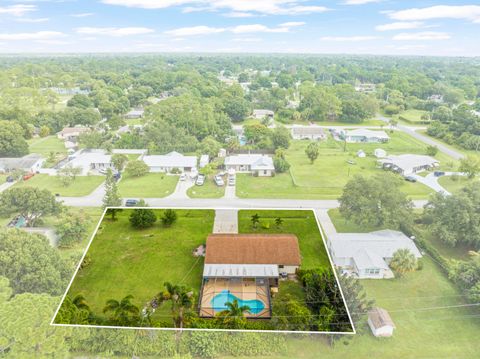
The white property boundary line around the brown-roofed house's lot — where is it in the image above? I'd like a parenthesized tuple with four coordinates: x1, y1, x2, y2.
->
(50, 207, 357, 335)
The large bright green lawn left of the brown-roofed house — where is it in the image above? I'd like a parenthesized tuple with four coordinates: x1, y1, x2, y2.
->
(61, 209, 214, 320)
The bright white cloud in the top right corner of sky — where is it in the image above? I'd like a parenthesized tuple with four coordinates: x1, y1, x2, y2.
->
(387, 5, 480, 23)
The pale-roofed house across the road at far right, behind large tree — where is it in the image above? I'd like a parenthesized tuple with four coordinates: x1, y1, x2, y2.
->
(378, 154, 440, 176)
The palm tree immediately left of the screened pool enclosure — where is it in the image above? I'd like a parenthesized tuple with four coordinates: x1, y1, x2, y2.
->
(156, 282, 194, 329)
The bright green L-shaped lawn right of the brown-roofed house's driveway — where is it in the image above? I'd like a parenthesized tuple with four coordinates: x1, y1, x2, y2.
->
(238, 210, 330, 269)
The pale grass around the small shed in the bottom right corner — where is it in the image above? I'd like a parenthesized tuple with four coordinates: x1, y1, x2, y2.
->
(285, 258, 480, 359)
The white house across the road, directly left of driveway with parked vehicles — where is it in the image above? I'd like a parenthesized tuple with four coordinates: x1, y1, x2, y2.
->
(142, 151, 197, 173)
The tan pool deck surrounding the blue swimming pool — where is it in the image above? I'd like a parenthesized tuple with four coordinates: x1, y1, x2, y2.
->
(199, 278, 271, 319)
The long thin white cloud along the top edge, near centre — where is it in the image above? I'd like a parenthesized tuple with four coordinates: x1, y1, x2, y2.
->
(102, 0, 329, 15)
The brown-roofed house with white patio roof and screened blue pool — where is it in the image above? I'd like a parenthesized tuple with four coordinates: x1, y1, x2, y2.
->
(199, 234, 301, 318)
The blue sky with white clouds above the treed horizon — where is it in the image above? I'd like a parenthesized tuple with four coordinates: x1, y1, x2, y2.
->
(0, 0, 480, 56)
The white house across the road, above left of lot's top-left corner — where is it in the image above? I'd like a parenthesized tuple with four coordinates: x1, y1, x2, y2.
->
(64, 149, 113, 176)
